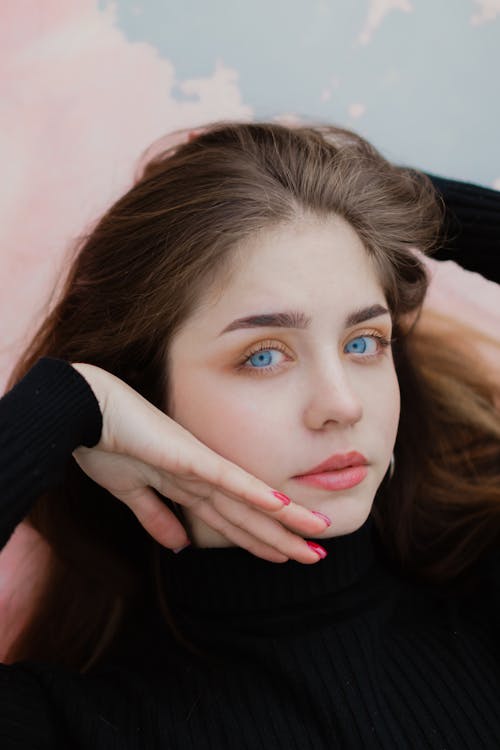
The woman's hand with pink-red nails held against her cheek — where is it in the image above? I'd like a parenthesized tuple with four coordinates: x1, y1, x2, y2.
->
(72, 363, 326, 563)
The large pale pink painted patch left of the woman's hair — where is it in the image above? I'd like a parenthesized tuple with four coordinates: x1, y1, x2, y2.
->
(0, 0, 252, 393)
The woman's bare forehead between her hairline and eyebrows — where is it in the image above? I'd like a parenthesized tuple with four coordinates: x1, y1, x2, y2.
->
(193, 217, 385, 319)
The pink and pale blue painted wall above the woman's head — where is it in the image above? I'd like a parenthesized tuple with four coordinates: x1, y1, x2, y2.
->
(0, 0, 500, 391)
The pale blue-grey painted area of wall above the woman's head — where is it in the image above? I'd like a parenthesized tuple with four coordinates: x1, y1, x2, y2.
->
(101, 0, 500, 185)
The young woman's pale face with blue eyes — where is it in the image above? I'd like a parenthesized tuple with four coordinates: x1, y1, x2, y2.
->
(169, 217, 400, 546)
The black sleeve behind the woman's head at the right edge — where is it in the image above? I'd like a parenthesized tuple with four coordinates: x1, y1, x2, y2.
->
(428, 174, 500, 284)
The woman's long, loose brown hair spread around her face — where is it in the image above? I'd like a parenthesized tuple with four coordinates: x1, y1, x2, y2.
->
(9, 123, 500, 670)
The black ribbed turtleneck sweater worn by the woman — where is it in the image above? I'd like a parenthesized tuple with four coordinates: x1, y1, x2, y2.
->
(0, 179, 500, 750)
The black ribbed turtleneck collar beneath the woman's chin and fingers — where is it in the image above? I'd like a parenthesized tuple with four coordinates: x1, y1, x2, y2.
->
(162, 516, 378, 616)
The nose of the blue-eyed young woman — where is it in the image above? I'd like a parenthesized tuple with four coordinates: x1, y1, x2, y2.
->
(304, 359, 363, 430)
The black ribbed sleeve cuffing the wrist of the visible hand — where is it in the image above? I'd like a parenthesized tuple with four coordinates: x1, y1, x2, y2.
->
(0, 357, 102, 549)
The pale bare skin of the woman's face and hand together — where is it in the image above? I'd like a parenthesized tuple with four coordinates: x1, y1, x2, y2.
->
(73, 216, 400, 563)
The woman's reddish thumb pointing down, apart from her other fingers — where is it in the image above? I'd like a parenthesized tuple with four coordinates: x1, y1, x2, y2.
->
(113, 487, 190, 549)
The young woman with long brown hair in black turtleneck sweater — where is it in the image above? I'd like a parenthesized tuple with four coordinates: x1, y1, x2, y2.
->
(0, 124, 500, 749)
